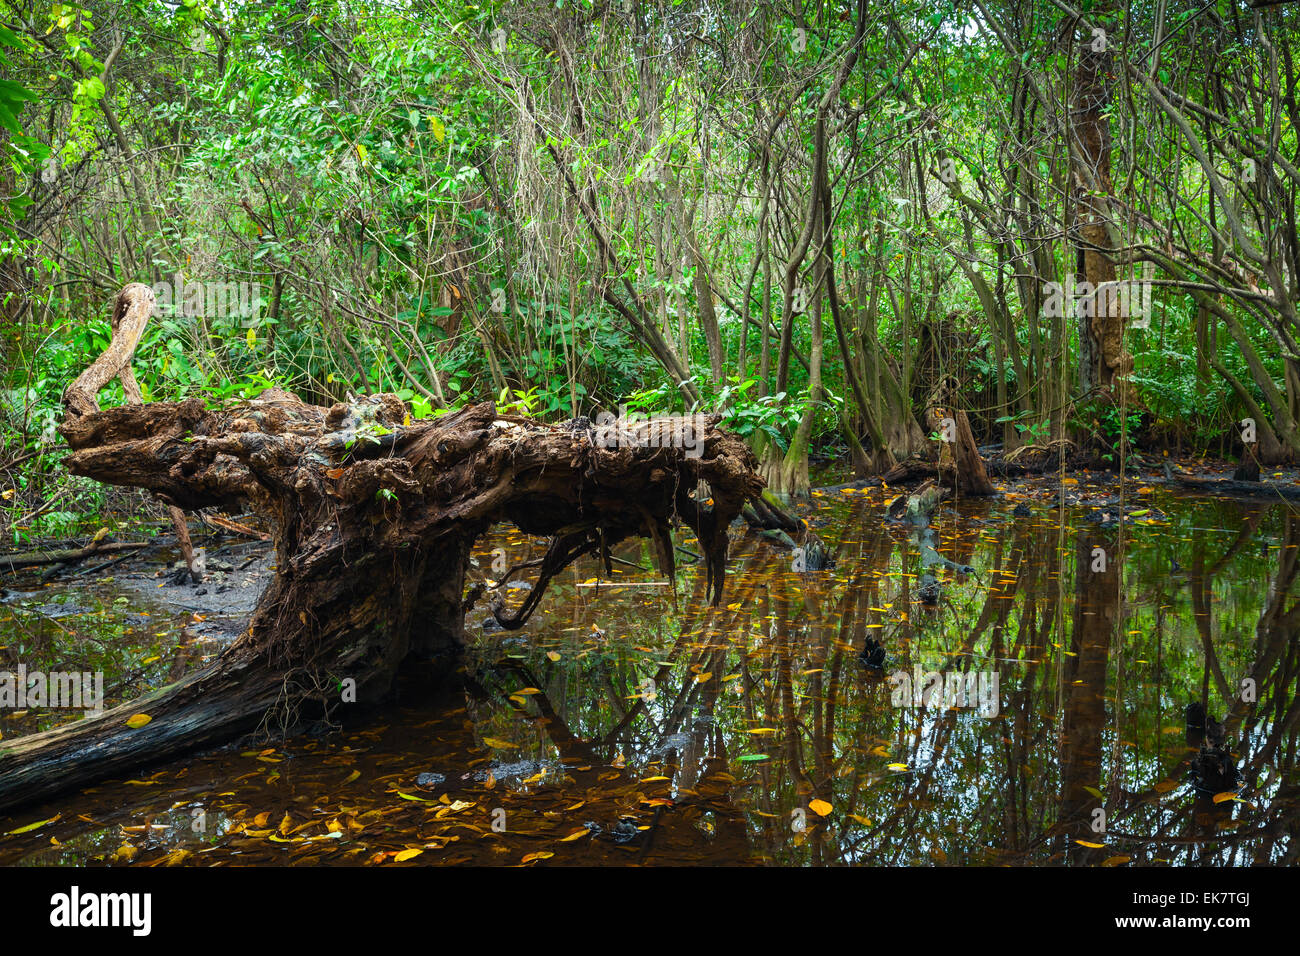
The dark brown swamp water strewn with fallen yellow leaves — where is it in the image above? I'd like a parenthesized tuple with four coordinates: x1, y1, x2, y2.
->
(0, 486, 1300, 866)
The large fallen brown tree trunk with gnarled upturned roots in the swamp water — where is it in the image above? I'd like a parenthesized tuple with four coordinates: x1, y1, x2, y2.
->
(0, 284, 763, 809)
